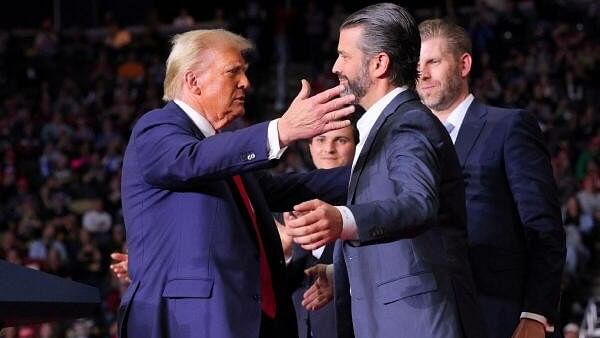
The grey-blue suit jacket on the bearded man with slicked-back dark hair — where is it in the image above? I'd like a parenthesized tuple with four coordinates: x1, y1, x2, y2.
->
(334, 90, 483, 338)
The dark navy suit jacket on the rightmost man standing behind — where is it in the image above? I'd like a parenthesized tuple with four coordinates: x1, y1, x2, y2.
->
(455, 99, 565, 338)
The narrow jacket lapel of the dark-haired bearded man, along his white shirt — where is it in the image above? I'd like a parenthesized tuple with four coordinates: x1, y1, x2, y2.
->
(346, 89, 417, 204)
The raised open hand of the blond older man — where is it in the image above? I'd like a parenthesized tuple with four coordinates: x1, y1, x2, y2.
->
(277, 79, 355, 146)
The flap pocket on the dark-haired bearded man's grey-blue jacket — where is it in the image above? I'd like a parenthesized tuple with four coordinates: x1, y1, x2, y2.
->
(377, 272, 437, 304)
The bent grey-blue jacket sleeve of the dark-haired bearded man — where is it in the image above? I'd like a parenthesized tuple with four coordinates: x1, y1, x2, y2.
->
(348, 127, 440, 242)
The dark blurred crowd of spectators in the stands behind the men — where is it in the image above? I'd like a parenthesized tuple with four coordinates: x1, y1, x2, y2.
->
(0, 0, 600, 338)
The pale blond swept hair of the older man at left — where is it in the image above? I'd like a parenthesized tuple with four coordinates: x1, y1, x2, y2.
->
(163, 29, 253, 101)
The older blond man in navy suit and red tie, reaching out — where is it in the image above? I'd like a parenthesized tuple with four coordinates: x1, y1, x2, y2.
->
(119, 30, 354, 338)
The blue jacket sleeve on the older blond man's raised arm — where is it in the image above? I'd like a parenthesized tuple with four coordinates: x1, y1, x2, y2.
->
(132, 118, 270, 189)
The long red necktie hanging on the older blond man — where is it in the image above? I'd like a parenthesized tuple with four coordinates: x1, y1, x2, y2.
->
(233, 175, 276, 318)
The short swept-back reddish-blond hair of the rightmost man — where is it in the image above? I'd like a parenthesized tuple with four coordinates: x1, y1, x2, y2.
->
(419, 19, 471, 56)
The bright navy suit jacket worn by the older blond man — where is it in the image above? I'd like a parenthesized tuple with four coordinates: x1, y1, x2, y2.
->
(120, 103, 348, 338)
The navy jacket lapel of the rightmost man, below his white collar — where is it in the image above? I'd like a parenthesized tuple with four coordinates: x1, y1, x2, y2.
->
(454, 99, 487, 166)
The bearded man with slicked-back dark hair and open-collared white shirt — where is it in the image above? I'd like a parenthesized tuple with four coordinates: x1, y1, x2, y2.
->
(285, 3, 482, 338)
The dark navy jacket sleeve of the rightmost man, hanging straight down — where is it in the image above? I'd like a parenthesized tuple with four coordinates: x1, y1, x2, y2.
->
(504, 112, 566, 323)
